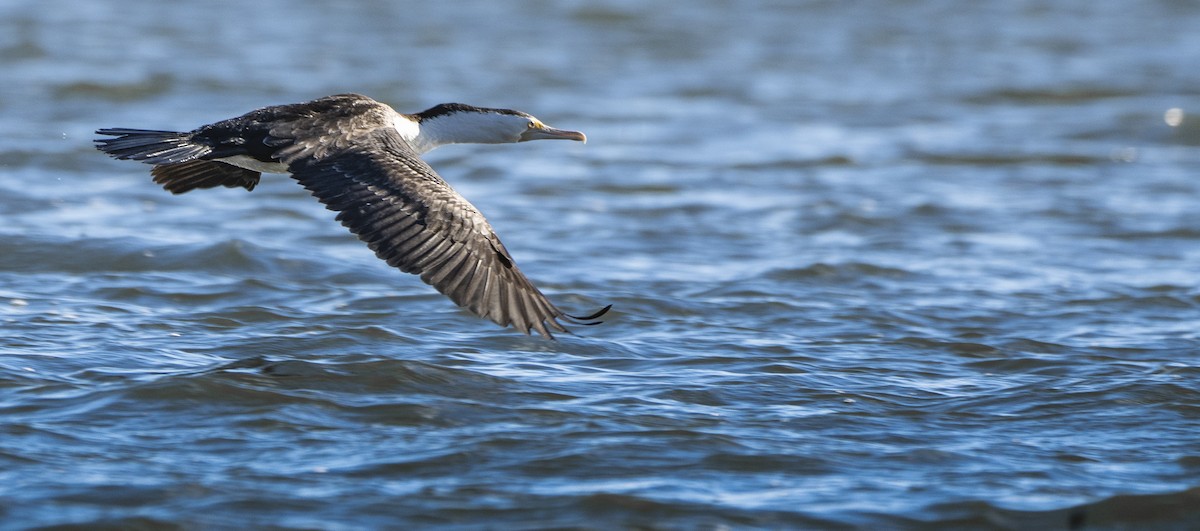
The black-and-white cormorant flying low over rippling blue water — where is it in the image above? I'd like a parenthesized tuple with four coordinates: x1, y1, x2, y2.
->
(95, 94, 612, 339)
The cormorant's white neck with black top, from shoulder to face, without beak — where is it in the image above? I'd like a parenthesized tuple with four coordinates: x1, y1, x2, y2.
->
(394, 113, 516, 154)
